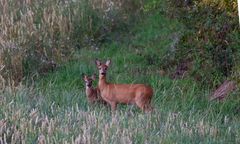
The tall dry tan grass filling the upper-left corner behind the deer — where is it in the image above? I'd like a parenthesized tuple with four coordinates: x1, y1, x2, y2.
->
(0, 0, 138, 85)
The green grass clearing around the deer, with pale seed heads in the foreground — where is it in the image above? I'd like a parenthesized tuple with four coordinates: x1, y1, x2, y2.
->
(0, 14, 240, 143)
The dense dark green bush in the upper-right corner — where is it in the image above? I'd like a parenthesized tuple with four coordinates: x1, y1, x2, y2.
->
(165, 0, 240, 85)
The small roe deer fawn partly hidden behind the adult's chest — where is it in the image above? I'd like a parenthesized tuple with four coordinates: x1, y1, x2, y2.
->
(83, 75, 105, 104)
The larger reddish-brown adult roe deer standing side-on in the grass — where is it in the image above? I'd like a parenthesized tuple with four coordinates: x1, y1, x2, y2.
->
(95, 60, 153, 111)
